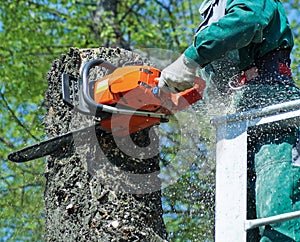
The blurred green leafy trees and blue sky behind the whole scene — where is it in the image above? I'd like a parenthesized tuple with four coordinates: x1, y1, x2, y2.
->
(0, 0, 300, 241)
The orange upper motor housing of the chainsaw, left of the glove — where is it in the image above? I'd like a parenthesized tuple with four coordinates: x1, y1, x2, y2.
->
(94, 66, 161, 111)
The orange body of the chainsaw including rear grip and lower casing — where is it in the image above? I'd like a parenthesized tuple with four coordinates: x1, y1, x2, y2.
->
(94, 66, 205, 136)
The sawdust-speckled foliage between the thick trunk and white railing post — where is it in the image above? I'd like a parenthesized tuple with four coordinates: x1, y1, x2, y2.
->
(160, 104, 215, 241)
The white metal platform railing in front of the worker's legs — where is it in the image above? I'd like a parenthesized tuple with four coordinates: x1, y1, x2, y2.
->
(212, 100, 300, 242)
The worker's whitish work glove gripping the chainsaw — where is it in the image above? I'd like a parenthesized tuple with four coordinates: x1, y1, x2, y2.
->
(158, 54, 199, 93)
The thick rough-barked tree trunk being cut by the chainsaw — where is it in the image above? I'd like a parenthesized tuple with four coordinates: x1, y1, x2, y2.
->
(44, 48, 166, 242)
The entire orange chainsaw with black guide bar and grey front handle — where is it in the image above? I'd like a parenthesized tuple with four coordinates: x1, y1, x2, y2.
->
(8, 59, 205, 162)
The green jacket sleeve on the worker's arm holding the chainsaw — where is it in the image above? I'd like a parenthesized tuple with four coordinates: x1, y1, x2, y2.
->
(184, 0, 276, 66)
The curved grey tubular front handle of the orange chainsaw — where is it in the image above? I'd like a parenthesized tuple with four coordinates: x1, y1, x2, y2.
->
(79, 59, 117, 117)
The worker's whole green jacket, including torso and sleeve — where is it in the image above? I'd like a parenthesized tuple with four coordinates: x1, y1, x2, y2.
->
(184, 0, 294, 70)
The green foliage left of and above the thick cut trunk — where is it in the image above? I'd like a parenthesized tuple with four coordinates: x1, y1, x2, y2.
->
(0, 0, 202, 241)
